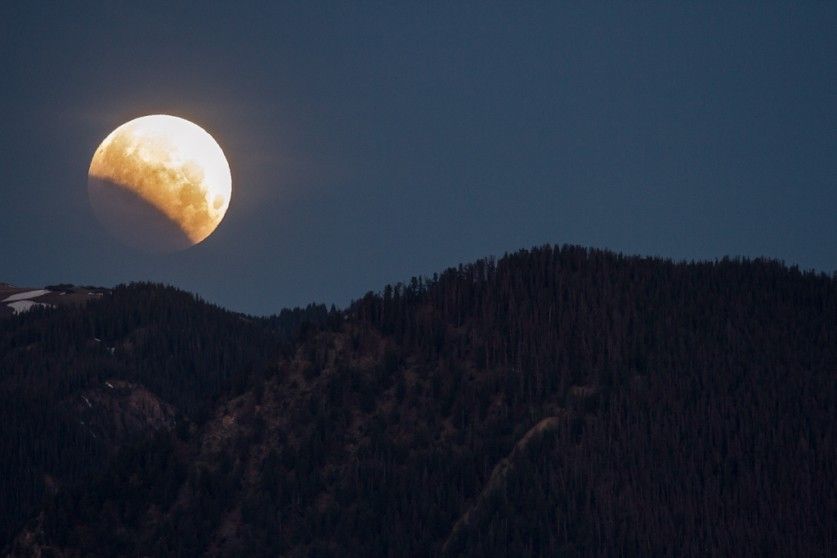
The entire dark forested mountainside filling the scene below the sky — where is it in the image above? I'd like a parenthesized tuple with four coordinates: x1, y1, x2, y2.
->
(0, 247, 837, 556)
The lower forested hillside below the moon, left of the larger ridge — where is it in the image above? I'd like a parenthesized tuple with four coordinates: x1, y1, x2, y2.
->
(0, 284, 334, 545)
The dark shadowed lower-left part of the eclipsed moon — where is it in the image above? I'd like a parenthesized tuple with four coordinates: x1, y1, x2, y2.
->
(87, 176, 194, 253)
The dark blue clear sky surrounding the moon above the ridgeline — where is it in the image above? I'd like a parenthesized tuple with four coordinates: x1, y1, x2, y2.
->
(0, 2, 837, 313)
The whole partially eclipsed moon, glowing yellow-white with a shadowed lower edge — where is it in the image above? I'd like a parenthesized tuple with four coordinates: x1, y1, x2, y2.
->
(87, 114, 232, 253)
